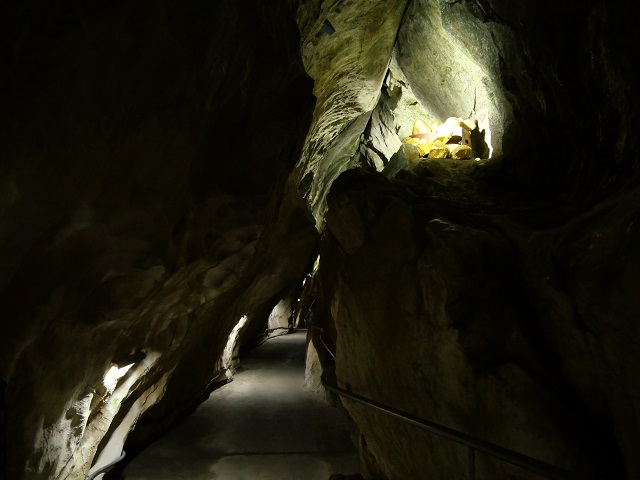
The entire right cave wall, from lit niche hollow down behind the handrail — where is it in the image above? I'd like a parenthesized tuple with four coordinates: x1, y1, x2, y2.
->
(304, 0, 640, 479)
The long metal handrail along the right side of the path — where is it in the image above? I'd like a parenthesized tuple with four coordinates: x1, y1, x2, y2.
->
(321, 365, 578, 480)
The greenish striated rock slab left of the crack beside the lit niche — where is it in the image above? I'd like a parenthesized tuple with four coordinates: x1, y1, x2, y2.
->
(296, 0, 407, 227)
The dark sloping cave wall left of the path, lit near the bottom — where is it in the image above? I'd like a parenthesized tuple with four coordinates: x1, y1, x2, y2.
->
(0, 1, 316, 479)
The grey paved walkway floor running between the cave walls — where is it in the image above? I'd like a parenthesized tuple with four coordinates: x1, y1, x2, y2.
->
(123, 331, 359, 480)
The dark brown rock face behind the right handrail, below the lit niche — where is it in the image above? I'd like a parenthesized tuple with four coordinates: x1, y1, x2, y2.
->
(318, 170, 640, 479)
